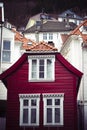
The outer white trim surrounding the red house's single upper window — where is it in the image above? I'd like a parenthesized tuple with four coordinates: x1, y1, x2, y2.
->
(28, 55, 55, 82)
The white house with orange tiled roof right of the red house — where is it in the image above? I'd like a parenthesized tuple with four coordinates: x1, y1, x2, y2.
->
(61, 21, 87, 130)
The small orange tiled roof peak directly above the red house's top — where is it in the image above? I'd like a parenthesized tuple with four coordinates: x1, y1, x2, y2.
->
(23, 41, 57, 51)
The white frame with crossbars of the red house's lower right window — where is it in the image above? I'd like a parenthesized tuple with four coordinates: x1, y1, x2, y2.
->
(43, 93, 64, 126)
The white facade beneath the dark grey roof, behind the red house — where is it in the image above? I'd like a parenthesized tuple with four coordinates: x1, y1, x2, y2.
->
(25, 32, 62, 51)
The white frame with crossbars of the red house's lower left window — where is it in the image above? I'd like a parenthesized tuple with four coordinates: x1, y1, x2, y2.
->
(19, 94, 40, 126)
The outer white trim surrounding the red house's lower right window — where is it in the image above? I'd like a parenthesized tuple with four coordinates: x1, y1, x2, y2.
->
(43, 93, 64, 126)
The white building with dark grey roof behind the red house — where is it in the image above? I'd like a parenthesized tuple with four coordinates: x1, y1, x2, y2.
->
(23, 20, 76, 51)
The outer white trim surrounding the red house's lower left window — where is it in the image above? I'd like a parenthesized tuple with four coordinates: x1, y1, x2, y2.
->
(19, 94, 40, 126)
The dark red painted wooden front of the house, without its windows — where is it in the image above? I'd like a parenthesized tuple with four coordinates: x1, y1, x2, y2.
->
(0, 54, 82, 130)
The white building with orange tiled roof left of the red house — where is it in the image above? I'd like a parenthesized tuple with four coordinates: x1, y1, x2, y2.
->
(0, 20, 29, 130)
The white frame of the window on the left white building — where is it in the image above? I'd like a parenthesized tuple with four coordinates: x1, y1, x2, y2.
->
(2, 39, 11, 62)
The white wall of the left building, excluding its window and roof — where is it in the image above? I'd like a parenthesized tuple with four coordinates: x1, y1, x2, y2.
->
(0, 27, 22, 100)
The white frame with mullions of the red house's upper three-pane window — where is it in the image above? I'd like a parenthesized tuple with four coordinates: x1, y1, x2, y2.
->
(28, 55, 55, 82)
